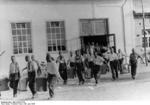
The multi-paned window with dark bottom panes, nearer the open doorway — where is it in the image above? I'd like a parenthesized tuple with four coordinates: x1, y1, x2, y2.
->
(46, 21, 66, 51)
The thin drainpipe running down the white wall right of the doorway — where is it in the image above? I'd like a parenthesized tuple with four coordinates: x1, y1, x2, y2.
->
(121, 0, 127, 63)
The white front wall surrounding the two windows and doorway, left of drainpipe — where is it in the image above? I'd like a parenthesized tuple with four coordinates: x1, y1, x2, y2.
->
(0, 1, 127, 74)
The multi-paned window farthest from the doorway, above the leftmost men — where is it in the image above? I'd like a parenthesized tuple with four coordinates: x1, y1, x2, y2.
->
(11, 22, 32, 54)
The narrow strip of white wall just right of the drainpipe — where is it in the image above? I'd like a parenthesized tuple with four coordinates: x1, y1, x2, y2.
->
(123, 0, 136, 55)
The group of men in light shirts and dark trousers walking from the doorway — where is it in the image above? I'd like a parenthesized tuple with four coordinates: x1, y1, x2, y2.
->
(0, 42, 141, 98)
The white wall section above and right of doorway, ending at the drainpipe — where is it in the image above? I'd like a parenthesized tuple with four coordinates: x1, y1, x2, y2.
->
(95, 4, 124, 51)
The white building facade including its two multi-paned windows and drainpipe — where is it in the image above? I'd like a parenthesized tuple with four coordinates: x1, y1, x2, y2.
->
(0, 0, 136, 75)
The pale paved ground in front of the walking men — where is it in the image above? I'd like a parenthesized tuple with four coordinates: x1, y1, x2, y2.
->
(1, 62, 150, 100)
